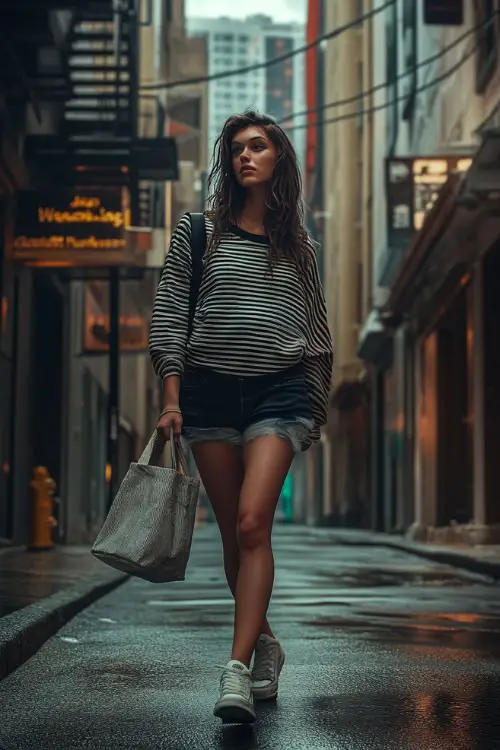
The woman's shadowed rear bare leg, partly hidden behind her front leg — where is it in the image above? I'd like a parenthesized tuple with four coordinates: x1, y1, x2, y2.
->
(192, 440, 274, 638)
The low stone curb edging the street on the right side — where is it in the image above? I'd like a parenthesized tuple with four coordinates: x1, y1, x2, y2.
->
(318, 533, 500, 582)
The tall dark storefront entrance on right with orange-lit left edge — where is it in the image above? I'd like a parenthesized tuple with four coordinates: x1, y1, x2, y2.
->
(415, 287, 474, 527)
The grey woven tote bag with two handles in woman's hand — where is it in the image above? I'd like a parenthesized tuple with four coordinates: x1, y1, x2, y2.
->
(92, 431, 200, 583)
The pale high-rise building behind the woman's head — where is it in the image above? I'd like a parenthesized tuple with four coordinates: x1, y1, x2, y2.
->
(188, 15, 306, 167)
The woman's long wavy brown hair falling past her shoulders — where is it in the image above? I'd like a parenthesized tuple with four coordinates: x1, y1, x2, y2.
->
(207, 111, 310, 271)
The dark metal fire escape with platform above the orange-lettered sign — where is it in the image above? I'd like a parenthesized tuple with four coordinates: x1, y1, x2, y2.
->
(21, 0, 177, 226)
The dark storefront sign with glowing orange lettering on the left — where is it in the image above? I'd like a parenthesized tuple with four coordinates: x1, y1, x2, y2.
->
(11, 189, 130, 265)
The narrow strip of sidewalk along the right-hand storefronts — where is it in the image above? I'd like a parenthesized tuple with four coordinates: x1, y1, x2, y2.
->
(310, 528, 500, 581)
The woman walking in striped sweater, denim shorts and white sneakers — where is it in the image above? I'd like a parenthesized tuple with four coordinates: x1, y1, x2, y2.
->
(150, 112, 333, 722)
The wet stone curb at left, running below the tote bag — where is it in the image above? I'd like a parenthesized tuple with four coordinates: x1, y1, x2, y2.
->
(0, 572, 129, 680)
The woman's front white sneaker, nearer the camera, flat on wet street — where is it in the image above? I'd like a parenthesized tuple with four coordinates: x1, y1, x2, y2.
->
(214, 659, 256, 724)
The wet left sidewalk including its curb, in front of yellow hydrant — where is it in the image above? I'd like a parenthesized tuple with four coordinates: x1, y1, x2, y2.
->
(0, 547, 127, 679)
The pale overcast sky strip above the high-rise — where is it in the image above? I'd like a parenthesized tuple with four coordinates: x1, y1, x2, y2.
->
(185, 0, 307, 23)
